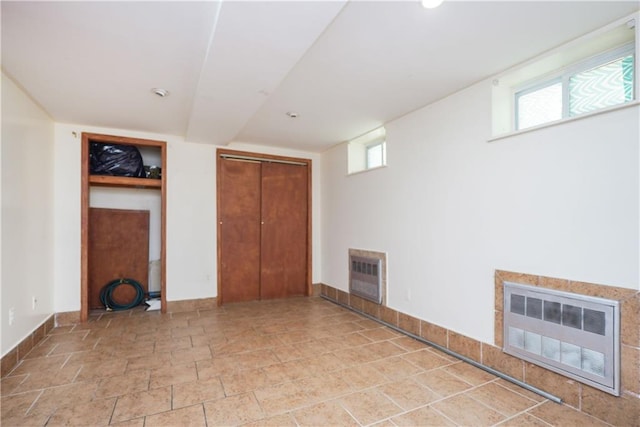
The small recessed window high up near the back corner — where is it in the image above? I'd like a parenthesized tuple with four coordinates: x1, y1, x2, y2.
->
(348, 127, 387, 174)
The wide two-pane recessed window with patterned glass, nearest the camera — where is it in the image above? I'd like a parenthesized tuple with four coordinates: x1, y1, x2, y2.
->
(491, 12, 640, 139)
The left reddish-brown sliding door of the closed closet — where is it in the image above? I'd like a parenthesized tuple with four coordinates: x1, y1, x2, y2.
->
(218, 159, 261, 302)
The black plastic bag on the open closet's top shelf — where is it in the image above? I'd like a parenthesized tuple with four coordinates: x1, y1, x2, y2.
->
(89, 142, 146, 178)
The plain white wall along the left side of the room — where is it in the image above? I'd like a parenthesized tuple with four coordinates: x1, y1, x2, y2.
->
(0, 74, 54, 356)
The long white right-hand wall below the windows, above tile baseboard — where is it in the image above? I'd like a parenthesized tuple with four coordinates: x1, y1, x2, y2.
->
(322, 81, 640, 342)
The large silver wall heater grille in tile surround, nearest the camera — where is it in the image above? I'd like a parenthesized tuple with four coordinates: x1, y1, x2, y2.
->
(504, 282, 620, 396)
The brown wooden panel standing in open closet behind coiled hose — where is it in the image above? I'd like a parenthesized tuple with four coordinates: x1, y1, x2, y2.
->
(88, 208, 149, 309)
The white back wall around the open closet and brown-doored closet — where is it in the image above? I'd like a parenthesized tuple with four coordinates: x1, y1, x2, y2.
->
(54, 124, 320, 312)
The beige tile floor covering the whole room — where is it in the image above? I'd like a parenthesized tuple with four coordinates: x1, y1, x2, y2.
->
(1, 297, 605, 426)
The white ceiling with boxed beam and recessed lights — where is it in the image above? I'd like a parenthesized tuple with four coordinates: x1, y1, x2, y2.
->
(1, 0, 638, 151)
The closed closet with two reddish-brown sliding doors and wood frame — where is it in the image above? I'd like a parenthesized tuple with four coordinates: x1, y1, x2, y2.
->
(217, 149, 311, 304)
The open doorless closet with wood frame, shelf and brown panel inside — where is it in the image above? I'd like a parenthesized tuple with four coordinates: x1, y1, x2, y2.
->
(80, 133, 167, 322)
